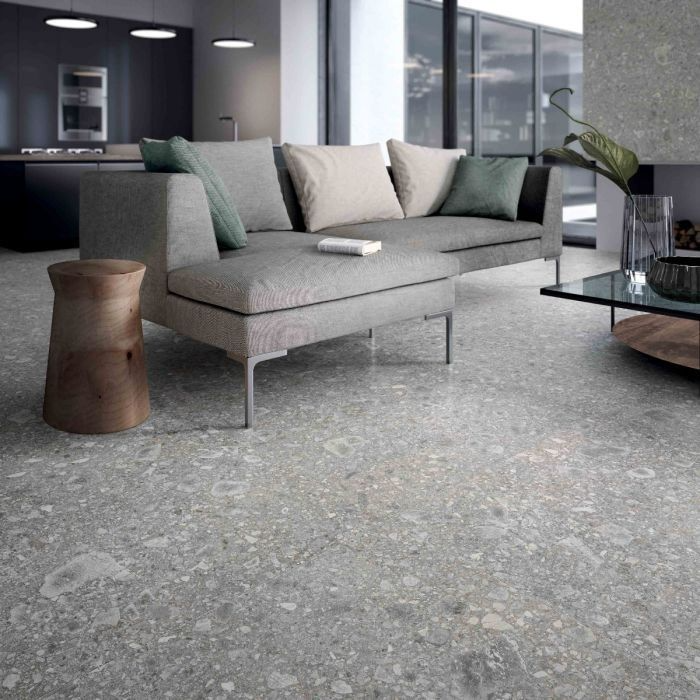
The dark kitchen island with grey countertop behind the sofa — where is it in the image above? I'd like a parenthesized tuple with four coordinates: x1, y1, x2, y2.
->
(0, 153, 143, 252)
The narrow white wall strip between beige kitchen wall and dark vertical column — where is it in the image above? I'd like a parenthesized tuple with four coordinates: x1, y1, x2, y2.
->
(280, 0, 319, 144)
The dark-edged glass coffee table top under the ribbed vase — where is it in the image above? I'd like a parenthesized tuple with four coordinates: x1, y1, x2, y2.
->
(540, 270, 700, 321)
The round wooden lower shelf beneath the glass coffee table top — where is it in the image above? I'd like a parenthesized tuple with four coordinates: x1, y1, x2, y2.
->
(613, 314, 700, 369)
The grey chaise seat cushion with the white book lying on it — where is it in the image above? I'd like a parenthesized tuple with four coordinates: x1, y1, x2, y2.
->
(168, 231, 459, 314)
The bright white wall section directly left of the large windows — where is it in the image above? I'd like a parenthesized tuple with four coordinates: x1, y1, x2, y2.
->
(350, 0, 405, 144)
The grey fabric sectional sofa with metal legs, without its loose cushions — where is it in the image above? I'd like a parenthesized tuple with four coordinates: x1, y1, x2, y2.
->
(80, 149, 561, 427)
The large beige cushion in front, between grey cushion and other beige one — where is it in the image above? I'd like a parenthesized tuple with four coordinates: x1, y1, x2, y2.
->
(282, 143, 403, 232)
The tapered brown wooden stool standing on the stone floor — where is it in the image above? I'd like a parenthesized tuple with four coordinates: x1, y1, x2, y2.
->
(44, 260, 149, 433)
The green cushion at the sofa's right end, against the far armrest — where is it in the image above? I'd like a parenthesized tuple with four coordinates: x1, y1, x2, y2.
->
(439, 156, 528, 221)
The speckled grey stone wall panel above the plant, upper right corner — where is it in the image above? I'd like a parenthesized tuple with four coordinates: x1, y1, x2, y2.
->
(583, 0, 700, 163)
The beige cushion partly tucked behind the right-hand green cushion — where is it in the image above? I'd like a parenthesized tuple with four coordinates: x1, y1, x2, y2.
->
(386, 139, 466, 219)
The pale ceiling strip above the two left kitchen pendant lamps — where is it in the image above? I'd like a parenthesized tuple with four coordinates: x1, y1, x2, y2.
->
(11, 0, 194, 27)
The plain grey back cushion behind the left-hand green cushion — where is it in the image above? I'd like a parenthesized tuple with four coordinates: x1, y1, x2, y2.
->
(192, 138, 292, 231)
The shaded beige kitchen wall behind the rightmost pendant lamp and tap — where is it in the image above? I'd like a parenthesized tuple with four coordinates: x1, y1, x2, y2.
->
(193, 0, 280, 143)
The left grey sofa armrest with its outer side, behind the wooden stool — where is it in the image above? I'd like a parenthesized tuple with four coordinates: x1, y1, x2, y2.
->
(80, 172, 219, 323)
